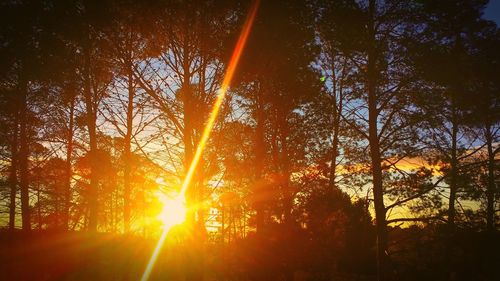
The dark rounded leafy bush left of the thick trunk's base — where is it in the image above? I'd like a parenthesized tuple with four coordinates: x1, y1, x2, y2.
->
(296, 173, 375, 280)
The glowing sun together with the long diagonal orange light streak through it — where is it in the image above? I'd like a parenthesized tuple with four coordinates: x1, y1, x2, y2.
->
(141, 0, 260, 281)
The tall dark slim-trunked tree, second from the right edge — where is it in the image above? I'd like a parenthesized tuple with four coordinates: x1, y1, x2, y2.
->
(413, 0, 492, 230)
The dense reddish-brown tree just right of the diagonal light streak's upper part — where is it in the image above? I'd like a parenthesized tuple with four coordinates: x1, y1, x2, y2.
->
(237, 1, 319, 232)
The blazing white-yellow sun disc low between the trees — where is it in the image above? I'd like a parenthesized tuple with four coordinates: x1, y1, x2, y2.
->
(157, 193, 187, 228)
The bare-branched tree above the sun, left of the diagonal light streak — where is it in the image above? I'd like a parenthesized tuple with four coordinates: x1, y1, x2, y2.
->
(134, 1, 239, 232)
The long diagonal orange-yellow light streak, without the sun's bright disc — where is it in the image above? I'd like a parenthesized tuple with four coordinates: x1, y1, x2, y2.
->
(141, 0, 260, 281)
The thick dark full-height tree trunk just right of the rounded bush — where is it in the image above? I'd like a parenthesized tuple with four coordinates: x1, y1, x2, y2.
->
(367, 0, 390, 281)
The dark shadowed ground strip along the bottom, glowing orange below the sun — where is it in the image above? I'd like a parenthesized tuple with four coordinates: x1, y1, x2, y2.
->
(0, 228, 500, 281)
